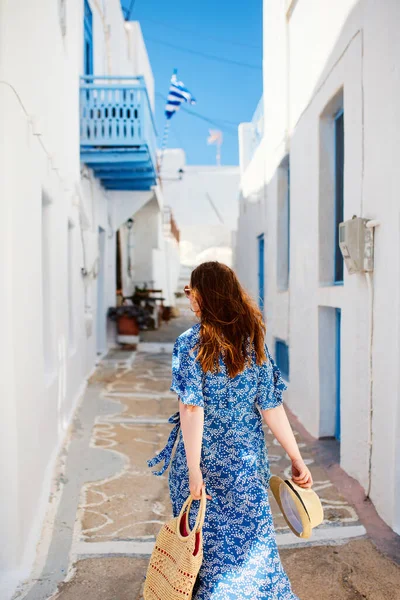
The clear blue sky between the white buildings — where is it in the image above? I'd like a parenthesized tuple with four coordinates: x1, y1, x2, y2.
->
(131, 0, 262, 165)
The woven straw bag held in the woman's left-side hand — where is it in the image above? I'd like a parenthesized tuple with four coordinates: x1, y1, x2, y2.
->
(144, 486, 206, 600)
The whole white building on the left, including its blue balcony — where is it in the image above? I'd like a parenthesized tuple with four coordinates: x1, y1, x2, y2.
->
(0, 0, 179, 597)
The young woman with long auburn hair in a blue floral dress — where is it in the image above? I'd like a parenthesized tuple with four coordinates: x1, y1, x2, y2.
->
(149, 261, 313, 600)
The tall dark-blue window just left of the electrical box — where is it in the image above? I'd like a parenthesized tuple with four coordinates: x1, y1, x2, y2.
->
(335, 109, 344, 283)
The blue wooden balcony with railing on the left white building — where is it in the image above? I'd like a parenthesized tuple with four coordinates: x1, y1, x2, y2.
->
(80, 76, 156, 190)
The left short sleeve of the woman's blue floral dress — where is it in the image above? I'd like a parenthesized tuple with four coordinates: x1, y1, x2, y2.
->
(170, 337, 204, 407)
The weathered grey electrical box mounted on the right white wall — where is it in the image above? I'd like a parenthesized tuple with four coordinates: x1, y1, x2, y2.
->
(339, 216, 374, 275)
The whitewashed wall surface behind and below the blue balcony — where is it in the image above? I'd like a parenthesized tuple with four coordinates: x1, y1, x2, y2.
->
(0, 0, 159, 598)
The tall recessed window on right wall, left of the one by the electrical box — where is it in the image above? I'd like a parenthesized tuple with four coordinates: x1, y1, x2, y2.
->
(277, 156, 290, 292)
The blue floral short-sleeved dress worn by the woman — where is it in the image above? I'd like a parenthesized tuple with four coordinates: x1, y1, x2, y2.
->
(148, 323, 299, 600)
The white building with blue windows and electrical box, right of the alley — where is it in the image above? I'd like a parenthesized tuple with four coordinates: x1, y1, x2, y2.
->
(235, 0, 400, 533)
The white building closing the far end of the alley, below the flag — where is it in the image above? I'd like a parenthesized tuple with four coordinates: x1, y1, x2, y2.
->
(161, 150, 239, 266)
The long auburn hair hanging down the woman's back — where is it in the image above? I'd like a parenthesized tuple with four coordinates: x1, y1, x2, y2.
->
(190, 261, 267, 377)
